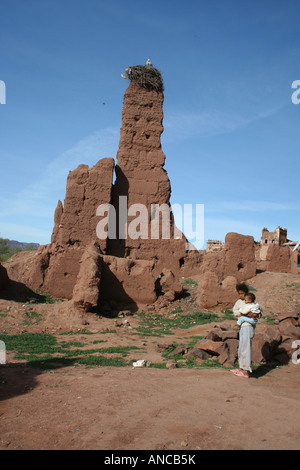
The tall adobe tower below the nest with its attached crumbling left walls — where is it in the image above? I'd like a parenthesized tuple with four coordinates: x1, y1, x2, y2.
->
(21, 66, 190, 309)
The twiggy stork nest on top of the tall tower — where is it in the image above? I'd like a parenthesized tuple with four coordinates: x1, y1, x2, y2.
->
(122, 65, 164, 91)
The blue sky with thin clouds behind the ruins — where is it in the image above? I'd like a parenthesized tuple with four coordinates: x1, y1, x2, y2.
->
(0, 0, 300, 248)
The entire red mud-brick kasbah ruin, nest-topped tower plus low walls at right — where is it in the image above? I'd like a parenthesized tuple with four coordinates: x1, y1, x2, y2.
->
(0, 64, 300, 448)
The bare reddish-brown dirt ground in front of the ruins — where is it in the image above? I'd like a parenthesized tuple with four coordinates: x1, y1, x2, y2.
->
(0, 273, 300, 451)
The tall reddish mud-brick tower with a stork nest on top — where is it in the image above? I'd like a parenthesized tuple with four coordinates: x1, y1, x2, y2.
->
(107, 60, 187, 272)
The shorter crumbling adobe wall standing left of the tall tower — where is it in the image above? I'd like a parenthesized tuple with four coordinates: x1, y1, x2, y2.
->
(28, 158, 114, 299)
